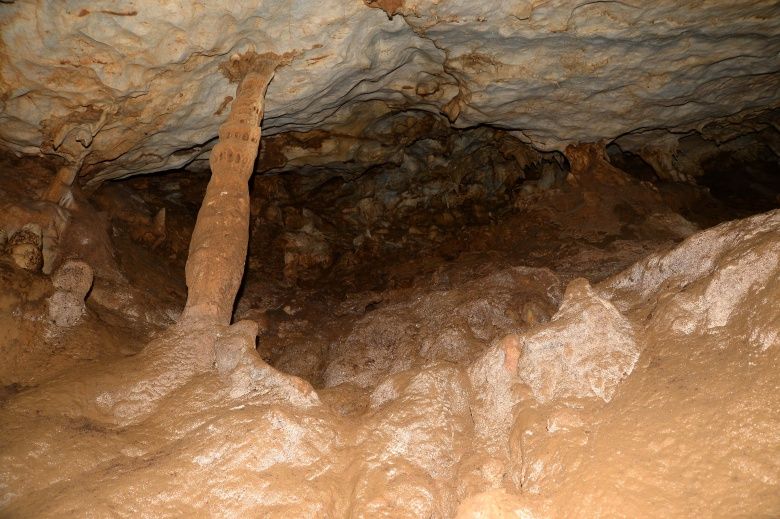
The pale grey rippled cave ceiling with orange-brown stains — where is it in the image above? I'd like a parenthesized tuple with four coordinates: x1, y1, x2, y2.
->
(0, 0, 780, 179)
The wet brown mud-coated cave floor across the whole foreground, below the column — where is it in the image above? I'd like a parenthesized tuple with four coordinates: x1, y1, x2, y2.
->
(0, 166, 780, 519)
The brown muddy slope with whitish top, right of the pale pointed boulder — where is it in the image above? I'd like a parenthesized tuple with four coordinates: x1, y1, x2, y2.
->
(510, 211, 780, 517)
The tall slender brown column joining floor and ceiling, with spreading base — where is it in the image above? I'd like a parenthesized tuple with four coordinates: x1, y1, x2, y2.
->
(2, 50, 311, 424)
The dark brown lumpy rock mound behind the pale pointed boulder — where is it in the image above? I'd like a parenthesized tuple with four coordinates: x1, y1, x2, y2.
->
(323, 267, 560, 387)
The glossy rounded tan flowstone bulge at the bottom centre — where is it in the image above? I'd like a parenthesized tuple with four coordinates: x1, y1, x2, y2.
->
(353, 365, 471, 518)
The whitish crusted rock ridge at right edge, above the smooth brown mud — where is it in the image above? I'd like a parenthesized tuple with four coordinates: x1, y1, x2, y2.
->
(599, 210, 780, 351)
